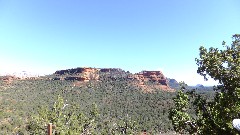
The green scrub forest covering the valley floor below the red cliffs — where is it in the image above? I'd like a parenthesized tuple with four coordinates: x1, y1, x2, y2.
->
(0, 74, 178, 134)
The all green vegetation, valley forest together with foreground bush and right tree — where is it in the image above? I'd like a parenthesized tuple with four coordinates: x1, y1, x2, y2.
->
(0, 35, 240, 135)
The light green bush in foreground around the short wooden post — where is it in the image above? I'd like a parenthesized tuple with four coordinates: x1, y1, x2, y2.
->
(27, 96, 98, 135)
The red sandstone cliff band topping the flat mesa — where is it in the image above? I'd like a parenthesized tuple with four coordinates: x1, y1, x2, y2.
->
(53, 67, 173, 91)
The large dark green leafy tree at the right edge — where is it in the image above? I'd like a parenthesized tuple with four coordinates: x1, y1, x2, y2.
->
(170, 34, 240, 135)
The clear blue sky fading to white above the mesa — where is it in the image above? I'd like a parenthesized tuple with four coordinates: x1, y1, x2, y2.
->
(0, 0, 240, 85)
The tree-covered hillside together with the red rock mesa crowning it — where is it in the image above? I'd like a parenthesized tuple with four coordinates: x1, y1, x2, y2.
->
(0, 65, 213, 134)
